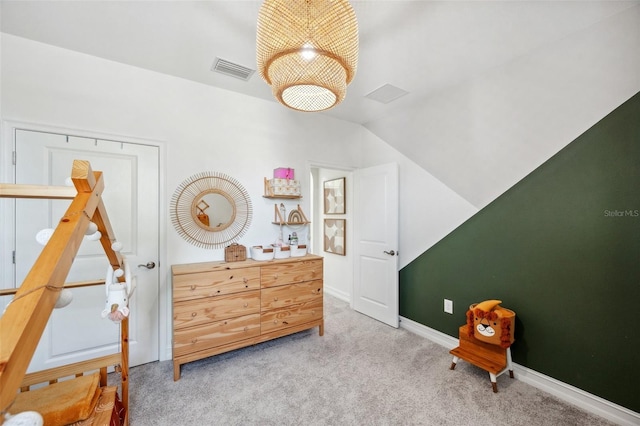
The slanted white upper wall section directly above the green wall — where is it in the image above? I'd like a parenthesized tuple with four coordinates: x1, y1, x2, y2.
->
(366, 5, 640, 208)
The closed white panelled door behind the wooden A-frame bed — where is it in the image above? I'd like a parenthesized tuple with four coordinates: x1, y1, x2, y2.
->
(14, 129, 159, 371)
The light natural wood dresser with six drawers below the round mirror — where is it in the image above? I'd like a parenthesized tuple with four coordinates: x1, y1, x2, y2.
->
(171, 254, 324, 380)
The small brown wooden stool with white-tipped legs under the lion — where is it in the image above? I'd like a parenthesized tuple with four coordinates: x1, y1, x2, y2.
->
(449, 325, 513, 392)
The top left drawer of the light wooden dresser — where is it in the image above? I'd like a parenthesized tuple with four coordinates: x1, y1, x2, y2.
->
(173, 268, 260, 302)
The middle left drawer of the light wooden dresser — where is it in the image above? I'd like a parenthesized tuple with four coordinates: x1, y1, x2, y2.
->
(173, 290, 260, 329)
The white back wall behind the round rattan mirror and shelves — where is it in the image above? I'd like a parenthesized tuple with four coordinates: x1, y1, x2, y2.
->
(0, 34, 364, 358)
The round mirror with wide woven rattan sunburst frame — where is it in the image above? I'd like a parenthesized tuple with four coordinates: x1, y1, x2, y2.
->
(171, 172, 253, 249)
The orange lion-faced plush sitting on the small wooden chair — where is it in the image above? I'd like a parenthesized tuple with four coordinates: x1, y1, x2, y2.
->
(467, 300, 516, 348)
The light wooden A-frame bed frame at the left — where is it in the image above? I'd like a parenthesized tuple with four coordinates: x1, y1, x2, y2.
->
(0, 160, 129, 425)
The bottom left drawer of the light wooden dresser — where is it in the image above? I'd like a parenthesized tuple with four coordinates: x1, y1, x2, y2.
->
(173, 314, 260, 357)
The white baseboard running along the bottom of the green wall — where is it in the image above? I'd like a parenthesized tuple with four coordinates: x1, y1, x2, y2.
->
(400, 317, 640, 426)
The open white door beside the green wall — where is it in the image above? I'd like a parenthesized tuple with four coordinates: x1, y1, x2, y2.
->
(353, 163, 399, 328)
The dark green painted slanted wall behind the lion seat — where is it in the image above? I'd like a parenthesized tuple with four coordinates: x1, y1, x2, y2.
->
(400, 94, 640, 412)
